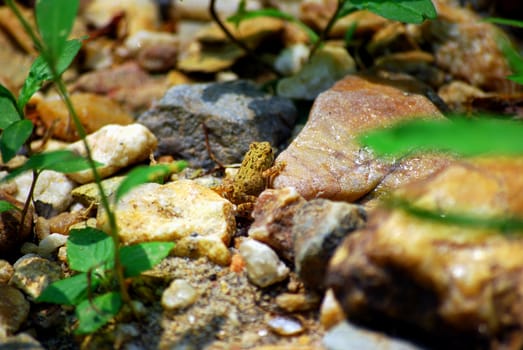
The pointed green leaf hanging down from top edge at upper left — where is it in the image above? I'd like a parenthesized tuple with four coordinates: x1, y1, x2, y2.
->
(35, 0, 80, 66)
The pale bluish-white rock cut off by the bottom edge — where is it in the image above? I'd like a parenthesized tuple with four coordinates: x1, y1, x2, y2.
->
(323, 322, 423, 350)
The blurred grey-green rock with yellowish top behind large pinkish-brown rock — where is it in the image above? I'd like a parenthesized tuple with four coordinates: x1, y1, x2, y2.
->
(277, 45, 356, 100)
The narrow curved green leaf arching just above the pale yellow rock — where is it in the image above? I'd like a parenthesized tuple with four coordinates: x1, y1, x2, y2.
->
(114, 160, 187, 202)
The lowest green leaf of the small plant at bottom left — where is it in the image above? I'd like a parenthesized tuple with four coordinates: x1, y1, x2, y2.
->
(75, 292, 122, 334)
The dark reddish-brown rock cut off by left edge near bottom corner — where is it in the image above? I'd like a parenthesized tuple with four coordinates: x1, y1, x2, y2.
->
(0, 285, 30, 338)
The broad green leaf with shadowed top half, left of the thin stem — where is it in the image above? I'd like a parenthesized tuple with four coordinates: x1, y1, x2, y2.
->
(67, 227, 114, 272)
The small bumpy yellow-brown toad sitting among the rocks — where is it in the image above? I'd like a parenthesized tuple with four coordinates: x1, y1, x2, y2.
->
(214, 142, 284, 217)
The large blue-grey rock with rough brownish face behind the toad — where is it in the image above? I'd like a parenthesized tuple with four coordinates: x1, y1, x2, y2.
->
(138, 81, 296, 167)
